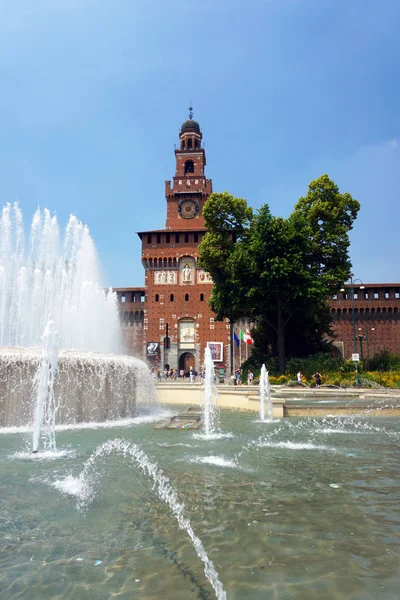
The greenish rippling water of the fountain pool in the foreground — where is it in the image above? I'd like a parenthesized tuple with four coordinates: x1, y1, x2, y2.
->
(0, 410, 400, 600)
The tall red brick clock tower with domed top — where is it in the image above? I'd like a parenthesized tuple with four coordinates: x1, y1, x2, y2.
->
(138, 108, 231, 372)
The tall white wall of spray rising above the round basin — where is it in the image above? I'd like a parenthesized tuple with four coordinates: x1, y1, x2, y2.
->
(0, 203, 121, 353)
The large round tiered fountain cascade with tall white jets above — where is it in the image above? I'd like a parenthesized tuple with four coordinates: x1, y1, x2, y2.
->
(0, 204, 153, 452)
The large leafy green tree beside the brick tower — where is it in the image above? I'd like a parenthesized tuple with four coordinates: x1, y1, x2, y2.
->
(199, 175, 359, 372)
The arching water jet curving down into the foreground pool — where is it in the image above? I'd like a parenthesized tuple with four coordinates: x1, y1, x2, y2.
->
(53, 439, 226, 600)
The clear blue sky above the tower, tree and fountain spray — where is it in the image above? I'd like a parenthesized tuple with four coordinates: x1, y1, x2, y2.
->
(0, 0, 400, 287)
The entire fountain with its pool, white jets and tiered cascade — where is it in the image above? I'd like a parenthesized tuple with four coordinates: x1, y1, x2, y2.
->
(0, 206, 400, 600)
